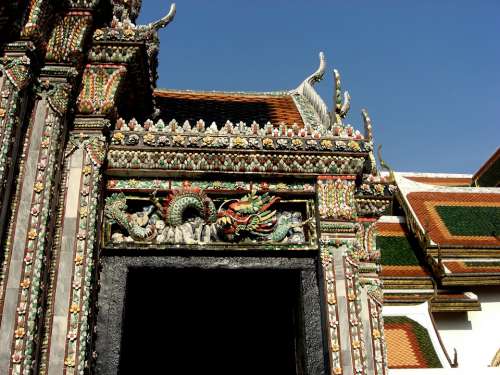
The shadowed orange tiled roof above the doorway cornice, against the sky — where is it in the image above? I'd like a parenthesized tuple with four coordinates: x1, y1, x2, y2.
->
(154, 90, 304, 127)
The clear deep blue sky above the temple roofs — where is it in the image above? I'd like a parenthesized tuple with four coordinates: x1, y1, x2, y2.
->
(138, 0, 500, 173)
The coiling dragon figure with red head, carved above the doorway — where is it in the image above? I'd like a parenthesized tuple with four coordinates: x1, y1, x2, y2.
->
(104, 188, 309, 244)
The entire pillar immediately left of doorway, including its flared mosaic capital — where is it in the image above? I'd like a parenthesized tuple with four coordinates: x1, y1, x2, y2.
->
(40, 58, 126, 374)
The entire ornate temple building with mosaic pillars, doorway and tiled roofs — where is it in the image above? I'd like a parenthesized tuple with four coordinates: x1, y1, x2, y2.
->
(0, 0, 500, 375)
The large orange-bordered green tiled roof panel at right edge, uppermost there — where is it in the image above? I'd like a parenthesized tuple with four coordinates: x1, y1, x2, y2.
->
(406, 192, 500, 247)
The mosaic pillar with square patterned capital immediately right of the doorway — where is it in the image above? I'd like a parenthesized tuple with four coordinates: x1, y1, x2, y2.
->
(318, 176, 371, 375)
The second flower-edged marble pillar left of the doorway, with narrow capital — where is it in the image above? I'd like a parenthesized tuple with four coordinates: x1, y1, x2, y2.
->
(0, 67, 75, 374)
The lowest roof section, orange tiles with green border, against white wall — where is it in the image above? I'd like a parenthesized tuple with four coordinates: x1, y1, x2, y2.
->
(384, 316, 443, 369)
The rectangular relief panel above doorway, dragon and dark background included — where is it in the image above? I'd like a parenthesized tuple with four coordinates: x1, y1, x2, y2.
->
(104, 188, 316, 249)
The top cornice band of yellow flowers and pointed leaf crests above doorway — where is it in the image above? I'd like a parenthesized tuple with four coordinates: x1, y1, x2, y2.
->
(112, 119, 372, 152)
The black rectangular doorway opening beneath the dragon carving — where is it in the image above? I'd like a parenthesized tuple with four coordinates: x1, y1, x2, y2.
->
(120, 268, 304, 375)
